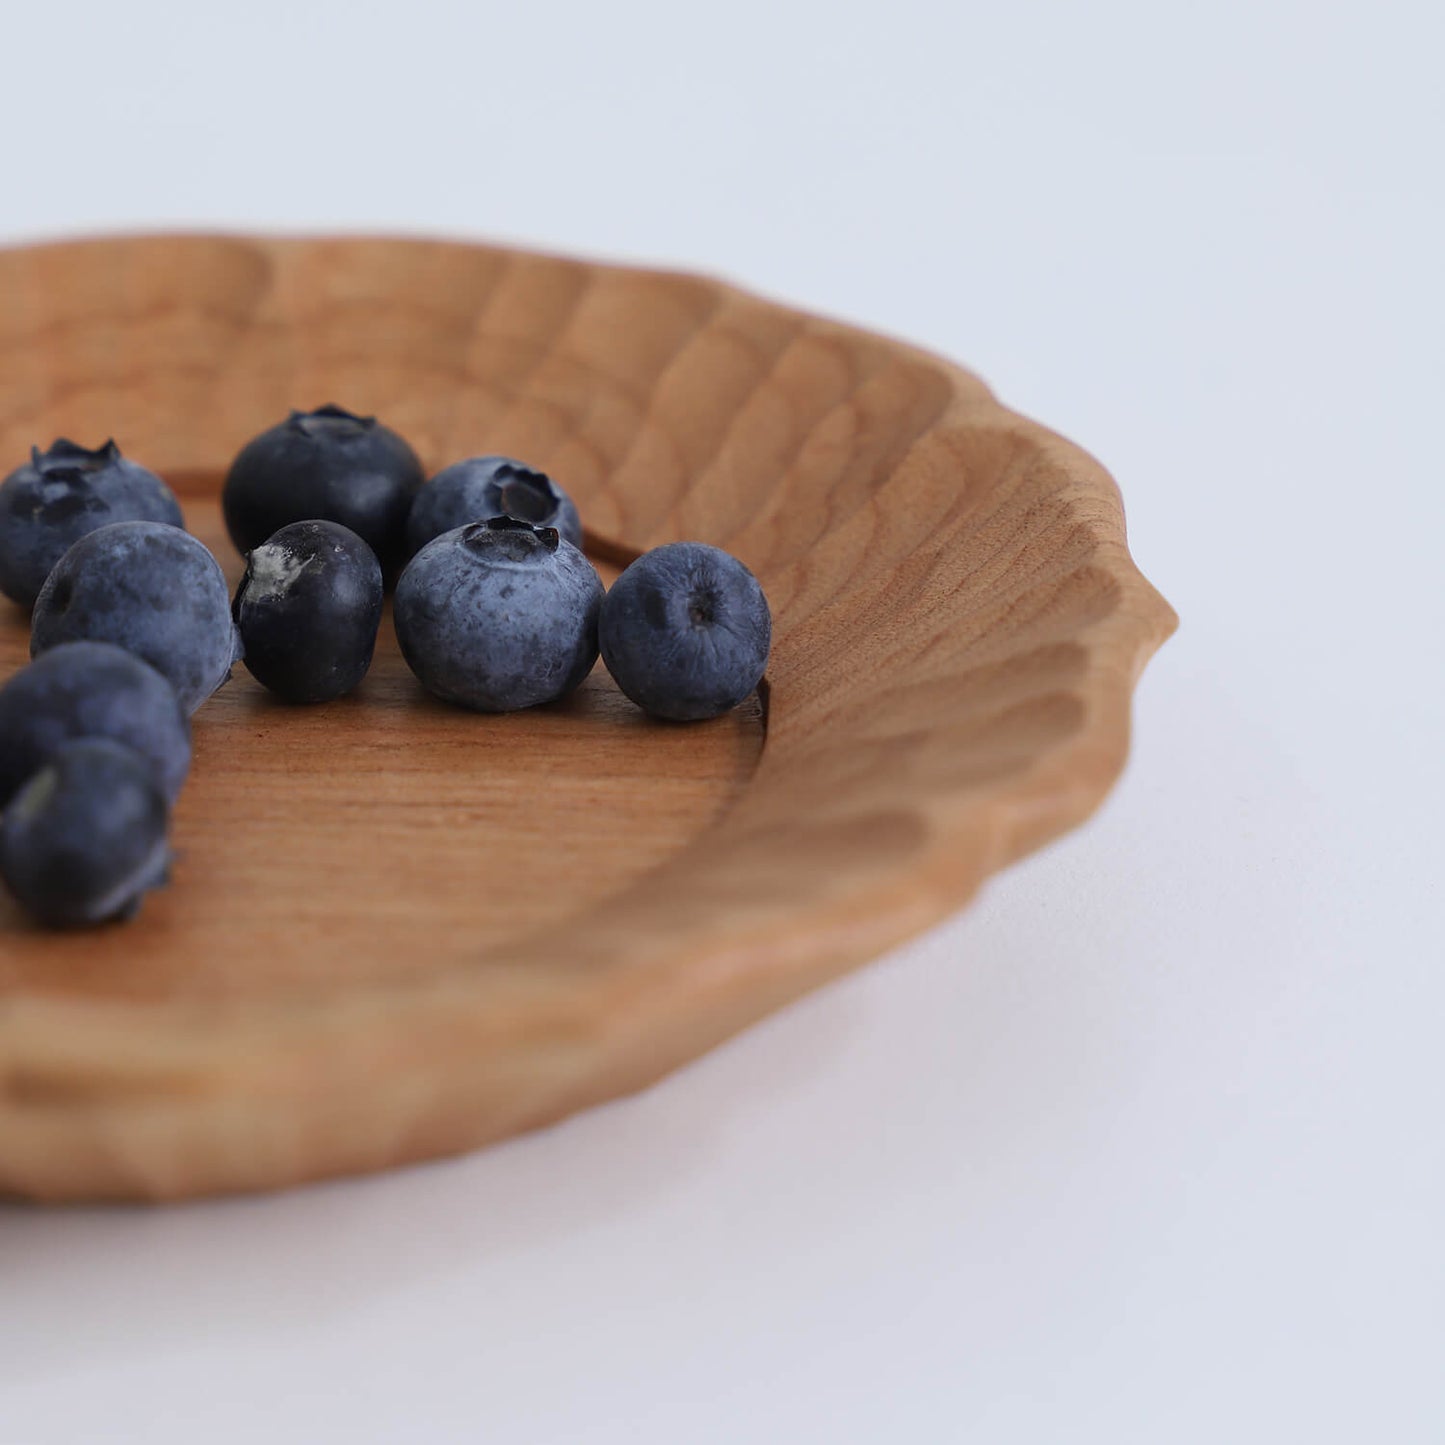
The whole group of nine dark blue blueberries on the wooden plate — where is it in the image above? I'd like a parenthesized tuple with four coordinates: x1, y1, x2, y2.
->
(0, 406, 772, 928)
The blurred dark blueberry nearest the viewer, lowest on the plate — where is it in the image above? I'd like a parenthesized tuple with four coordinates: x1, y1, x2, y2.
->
(0, 737, 171, 928)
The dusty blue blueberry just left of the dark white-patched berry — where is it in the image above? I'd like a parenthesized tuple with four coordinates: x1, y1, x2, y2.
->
(30, 522, 240, 712)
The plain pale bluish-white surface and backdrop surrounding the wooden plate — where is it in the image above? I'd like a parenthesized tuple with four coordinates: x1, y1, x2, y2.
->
(0, 0, 1445, 1445)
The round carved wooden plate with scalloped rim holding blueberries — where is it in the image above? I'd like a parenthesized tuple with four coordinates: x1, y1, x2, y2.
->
(0, 237, 1173, 1199)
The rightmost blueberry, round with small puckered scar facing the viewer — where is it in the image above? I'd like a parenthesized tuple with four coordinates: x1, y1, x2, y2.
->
(598, 542, 773, 723)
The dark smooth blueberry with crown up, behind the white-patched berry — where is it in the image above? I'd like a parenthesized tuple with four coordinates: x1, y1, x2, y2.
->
(221, 406, 423, 571)
